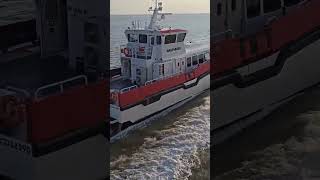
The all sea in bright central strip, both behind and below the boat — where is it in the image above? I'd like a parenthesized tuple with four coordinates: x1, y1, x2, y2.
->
(110, 14, 210, 179)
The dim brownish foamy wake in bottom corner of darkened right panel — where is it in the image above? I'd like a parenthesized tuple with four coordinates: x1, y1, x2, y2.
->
(215, 111, 320, 180)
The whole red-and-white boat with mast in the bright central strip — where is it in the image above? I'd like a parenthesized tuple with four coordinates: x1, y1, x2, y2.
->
(110, 0, 210, 142)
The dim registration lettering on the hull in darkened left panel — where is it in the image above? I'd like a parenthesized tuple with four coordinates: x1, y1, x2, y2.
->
(0, 136, 32, 155)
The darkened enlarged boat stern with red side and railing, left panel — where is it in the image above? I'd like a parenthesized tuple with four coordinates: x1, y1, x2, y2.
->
(0, 0, 109, 180)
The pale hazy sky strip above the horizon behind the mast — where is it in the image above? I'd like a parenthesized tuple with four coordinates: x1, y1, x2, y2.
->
(110, 0, 210, 14)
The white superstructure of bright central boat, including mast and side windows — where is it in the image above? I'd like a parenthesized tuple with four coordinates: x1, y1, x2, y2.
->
(117, 0, 209, 89)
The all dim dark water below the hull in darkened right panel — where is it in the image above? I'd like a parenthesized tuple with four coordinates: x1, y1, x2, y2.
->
(213, 87, 320, 180)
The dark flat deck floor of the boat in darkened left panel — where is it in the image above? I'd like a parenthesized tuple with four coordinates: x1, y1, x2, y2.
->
(0, 54, 77, 93)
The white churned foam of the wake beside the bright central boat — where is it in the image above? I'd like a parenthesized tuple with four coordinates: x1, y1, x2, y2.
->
(111, 96, 210, 179)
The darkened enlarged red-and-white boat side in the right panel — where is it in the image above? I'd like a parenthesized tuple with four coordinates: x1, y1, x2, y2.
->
(211, 0, 320, 144)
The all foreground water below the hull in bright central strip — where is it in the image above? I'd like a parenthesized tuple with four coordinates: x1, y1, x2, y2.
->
(111, 93, 210, 179)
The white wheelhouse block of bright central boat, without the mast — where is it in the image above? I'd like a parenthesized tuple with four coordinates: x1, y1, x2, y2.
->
(121, 29, 187, 85)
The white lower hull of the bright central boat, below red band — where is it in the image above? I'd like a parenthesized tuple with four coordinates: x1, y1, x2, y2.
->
(110, 74, 210, 142)
